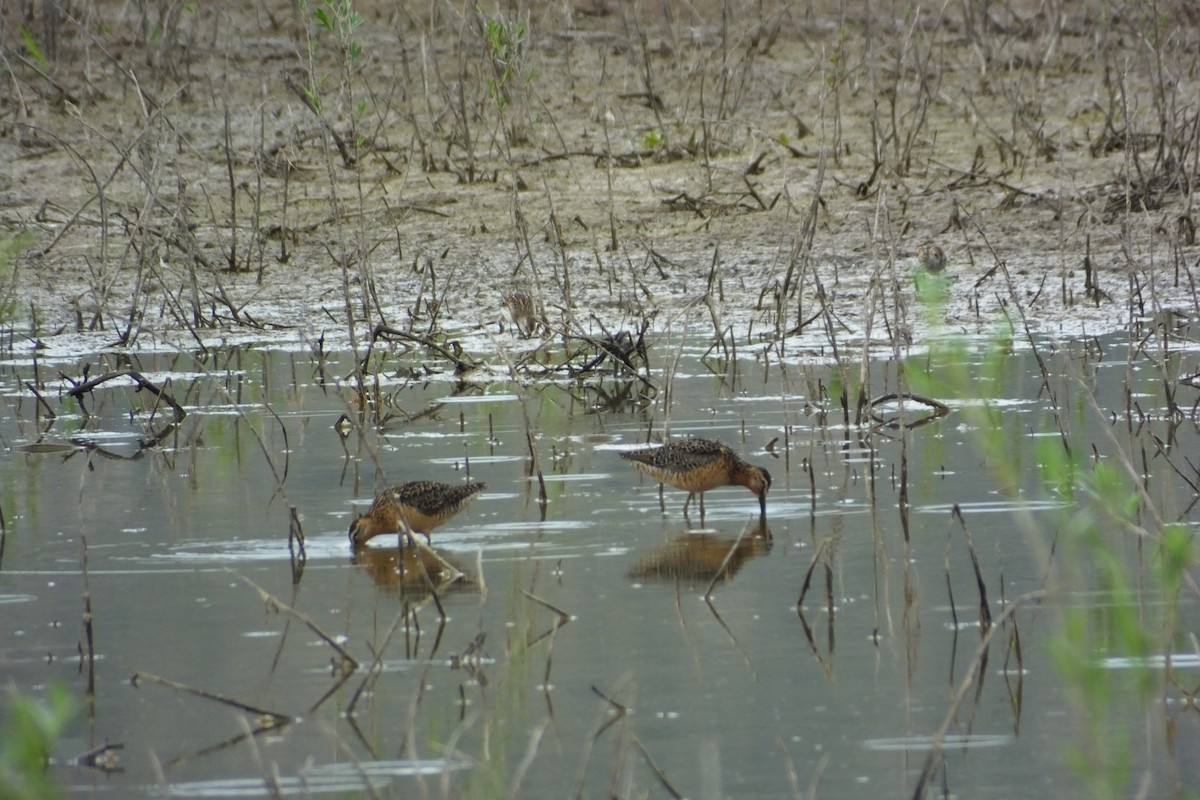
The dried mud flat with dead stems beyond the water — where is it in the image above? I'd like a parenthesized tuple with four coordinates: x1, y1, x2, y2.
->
(0, 0, 1200, 355)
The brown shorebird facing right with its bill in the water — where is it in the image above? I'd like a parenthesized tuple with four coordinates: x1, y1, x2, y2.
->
(620, 438, 770, 519)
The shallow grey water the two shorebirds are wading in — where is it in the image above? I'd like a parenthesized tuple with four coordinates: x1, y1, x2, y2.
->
(0, 333, 1200, 798)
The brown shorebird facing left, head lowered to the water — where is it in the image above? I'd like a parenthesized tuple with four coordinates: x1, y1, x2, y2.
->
(350, 481, 486, 547)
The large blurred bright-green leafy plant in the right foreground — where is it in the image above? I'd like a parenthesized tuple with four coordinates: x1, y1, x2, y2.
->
(905, 303, 1196, 798)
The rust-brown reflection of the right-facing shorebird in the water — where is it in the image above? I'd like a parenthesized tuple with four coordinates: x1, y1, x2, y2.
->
(626, 519, 772, 583)
